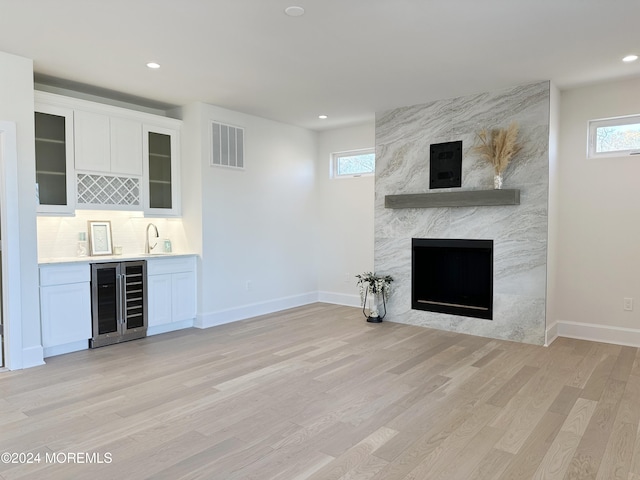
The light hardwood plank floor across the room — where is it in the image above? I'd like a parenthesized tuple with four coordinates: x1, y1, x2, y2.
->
(0, 304, 640, 480)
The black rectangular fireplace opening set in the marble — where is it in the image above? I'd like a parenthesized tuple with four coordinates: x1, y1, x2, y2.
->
(411, 238, 493, 320)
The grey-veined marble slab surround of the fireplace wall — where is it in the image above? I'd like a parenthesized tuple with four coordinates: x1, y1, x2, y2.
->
(374, 82, 550, 345)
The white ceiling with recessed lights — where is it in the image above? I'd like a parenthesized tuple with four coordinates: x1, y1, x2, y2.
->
(0, 0, 640, 130)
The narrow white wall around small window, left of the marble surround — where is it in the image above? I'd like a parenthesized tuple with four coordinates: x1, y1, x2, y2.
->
(316, 122, 375, 306)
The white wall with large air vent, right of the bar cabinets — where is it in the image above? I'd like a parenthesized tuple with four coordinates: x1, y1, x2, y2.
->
(182, 104, 318, 326)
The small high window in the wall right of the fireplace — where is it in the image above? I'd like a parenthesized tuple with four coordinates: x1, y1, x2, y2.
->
(588, 115, 640, 158)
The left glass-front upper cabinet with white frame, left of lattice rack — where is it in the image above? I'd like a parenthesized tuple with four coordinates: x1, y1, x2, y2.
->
(35, 105, 75, 214)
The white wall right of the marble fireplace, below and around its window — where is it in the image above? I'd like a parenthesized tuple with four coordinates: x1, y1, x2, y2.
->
(555, 78, 640, 345)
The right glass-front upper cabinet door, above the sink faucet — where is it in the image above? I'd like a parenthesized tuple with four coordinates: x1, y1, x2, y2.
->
(143, 125, 180, 216)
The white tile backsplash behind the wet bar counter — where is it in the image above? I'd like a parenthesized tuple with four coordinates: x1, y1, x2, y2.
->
(38, 210, 192, 261)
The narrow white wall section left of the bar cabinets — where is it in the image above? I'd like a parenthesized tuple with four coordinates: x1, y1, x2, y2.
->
(0, 52, 42, 368)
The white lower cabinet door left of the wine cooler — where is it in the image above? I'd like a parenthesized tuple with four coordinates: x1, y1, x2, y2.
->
(40, 282, 91, 348)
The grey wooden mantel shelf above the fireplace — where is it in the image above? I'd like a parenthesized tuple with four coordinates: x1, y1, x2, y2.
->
(384, 189, 520, 208)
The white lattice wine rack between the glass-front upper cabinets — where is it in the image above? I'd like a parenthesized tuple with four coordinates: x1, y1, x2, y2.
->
(77, 173, 141, 207)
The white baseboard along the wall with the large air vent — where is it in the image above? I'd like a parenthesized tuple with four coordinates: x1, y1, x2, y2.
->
(193, 292, 318, 328)
